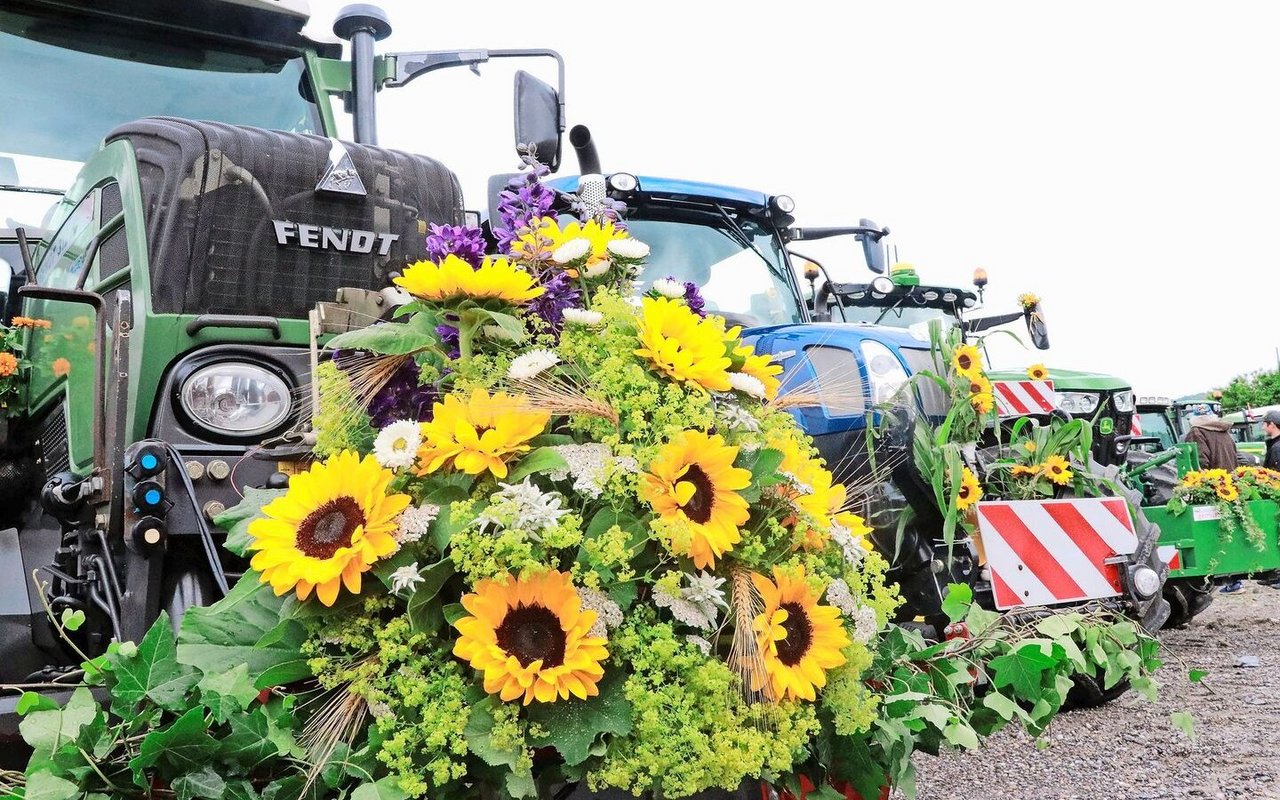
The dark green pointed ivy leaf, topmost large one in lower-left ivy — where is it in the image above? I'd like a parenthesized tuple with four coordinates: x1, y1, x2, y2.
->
(108, 611, 198, 719)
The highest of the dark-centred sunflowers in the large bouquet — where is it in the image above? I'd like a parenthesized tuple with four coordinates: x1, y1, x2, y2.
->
(640, 430, 751, 570)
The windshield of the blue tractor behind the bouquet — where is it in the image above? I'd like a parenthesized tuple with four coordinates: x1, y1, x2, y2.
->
(627, 214, 803, 328)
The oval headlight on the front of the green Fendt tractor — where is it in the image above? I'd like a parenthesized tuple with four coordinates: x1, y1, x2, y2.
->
(178, 361, 292, 436)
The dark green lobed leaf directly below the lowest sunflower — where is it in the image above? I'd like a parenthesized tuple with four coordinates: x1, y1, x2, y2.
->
(529, 671, 631, 767)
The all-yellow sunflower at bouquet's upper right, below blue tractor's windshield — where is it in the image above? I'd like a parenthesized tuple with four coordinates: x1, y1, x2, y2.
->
(635, 297, 733, 392)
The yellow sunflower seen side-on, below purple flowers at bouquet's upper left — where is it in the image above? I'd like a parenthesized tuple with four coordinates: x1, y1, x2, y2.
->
(394, 253, 545, 306)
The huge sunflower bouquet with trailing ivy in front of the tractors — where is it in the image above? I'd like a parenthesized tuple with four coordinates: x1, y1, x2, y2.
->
(0, 163, 1172, 800)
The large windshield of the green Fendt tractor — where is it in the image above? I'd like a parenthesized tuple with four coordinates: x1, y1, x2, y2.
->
(0, 12, 320, 227)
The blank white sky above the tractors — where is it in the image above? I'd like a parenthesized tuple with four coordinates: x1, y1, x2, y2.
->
(311, 0, 1280, 396)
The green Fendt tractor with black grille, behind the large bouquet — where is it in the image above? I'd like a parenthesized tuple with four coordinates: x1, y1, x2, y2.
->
(0, 0, 563, 741)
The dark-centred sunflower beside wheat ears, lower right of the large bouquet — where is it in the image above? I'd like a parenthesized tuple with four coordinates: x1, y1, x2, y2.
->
(751, 567, 849, 701)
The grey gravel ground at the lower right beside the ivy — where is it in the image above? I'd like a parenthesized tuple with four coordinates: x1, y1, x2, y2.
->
(916, 582, 1280, 800)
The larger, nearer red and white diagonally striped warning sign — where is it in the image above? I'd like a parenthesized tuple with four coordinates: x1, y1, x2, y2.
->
(978, 497, 1138, 609)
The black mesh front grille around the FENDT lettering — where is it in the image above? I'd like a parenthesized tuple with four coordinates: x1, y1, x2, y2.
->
(108, 118, 462, 317)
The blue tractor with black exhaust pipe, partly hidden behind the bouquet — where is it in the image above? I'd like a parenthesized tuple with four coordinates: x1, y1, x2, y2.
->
(535, 127, 1167, 632)
